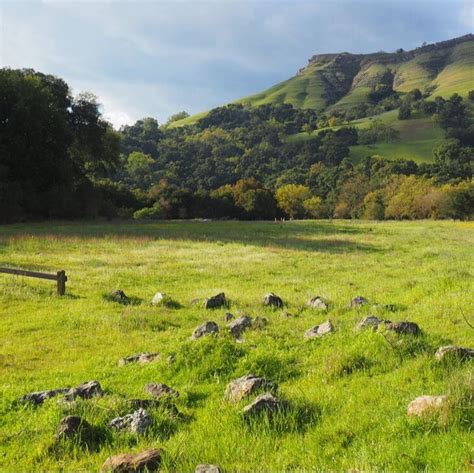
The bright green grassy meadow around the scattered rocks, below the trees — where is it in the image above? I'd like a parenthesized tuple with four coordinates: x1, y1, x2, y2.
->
(0, 221, 474, 472)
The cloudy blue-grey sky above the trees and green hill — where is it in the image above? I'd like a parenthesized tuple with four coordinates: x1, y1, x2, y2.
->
(0, 0, 474, 127)
